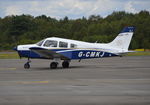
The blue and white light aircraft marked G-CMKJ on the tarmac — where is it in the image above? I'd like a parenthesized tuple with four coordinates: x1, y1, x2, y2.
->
(14, 27, 135, 69)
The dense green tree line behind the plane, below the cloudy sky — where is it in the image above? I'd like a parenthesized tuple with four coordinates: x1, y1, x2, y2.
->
(0, 11, 150, 50)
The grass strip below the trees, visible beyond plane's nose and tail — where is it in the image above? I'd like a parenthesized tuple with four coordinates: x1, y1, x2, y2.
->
(0, 51, 150, 59)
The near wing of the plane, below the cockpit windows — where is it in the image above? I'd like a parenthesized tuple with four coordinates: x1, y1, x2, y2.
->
(30, 47, 69, 60)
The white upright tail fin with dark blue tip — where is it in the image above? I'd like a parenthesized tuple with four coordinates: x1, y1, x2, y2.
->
(109, 27, 135, 51)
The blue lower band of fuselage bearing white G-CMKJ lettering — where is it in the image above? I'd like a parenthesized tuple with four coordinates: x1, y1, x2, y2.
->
(18, 49, 117, 59)
